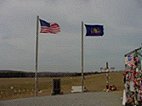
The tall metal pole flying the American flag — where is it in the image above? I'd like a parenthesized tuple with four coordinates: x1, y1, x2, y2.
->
(35, 16, 39, 96)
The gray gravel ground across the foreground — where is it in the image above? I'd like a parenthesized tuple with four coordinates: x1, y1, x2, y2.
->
(0, 92, 122, 106)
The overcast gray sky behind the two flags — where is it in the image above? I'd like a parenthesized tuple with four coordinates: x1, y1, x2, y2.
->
(0, 0, 142, 72)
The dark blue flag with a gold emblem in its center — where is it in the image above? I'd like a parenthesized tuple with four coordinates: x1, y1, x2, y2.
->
(85, 25, 104, 36)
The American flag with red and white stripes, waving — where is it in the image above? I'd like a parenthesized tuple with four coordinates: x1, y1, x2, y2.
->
(40, 19, 60, 34)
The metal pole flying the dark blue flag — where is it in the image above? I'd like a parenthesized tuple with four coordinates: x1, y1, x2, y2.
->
(81, 21, 84, 92)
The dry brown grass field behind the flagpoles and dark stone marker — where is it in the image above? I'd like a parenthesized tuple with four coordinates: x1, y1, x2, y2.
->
(0, 72, 123, 100)
